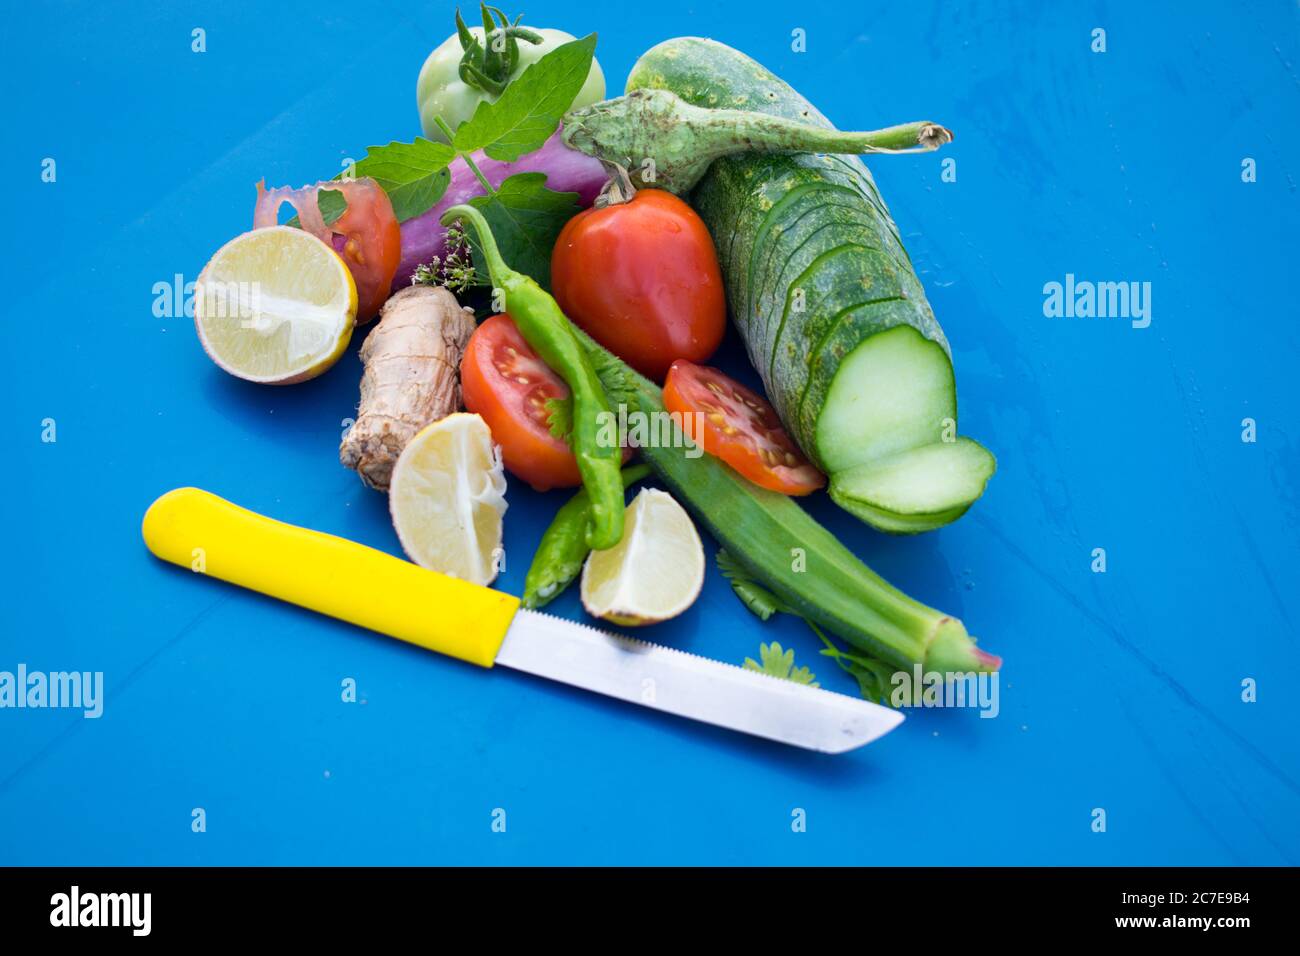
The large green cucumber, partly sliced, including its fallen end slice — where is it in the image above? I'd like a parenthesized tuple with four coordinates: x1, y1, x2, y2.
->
(628, 36, 995, 533)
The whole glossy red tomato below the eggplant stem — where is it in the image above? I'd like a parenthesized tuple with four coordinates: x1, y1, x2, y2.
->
(551, 189, 727, 381)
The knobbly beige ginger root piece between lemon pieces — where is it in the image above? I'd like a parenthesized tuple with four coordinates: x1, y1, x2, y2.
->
(338, 285, 475, 492)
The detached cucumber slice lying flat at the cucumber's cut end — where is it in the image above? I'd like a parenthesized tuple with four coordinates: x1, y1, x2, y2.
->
(831, 438, 997, 535)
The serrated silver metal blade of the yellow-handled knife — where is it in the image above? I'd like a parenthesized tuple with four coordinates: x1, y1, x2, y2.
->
(497, 610, 902, 753)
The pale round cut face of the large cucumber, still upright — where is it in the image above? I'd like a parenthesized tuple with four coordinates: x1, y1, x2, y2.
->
(815, 325, 957, 475)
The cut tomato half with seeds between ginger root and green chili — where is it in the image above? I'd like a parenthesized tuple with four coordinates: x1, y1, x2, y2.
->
(460, 315, 581, 492)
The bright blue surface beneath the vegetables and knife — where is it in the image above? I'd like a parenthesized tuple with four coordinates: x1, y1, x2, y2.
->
(0, 0, 1300, 864)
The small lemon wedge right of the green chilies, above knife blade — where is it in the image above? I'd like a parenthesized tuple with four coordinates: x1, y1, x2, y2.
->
(582, 488, 705, 627)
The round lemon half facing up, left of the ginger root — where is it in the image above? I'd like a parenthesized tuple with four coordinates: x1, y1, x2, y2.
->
(194, 226, 356, 385)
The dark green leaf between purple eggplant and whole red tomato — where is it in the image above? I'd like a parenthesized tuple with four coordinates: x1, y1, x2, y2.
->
(469, 172, 581, 289)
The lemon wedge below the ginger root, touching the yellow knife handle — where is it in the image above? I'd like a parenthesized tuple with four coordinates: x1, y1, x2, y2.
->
(376, 412, 506, 587)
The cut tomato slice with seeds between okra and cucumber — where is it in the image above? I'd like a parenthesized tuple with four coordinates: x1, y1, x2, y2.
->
(663, 359, 826, 494)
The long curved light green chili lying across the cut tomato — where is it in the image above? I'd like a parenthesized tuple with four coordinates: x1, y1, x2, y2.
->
(442, 206, 623, 550)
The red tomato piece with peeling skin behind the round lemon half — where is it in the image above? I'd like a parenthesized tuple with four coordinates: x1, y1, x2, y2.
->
(252, 177, 402, 325)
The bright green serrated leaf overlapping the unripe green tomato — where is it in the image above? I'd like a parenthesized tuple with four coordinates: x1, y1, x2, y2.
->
(452, 34, 595, 161)
